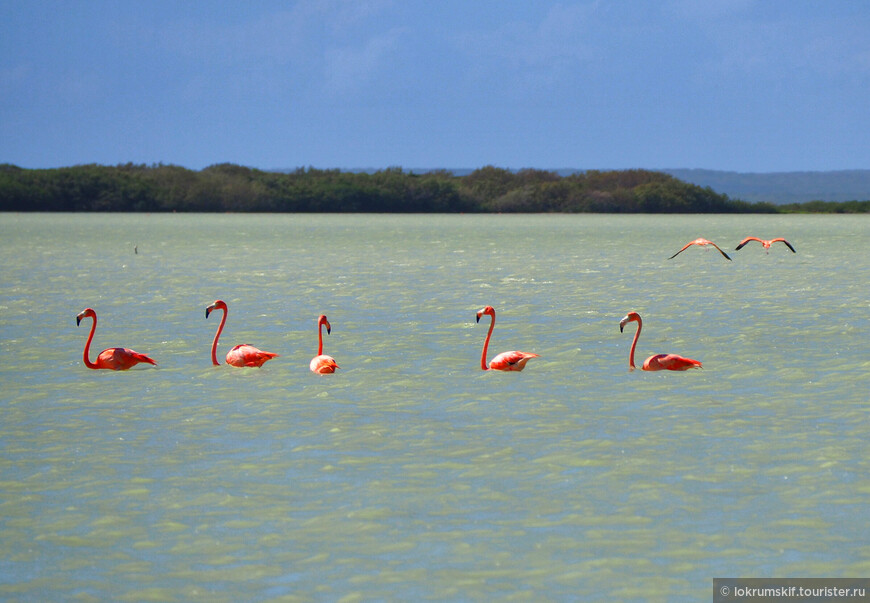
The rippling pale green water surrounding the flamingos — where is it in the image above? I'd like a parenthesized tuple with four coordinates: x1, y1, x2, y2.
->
(0, 214, 870, 601)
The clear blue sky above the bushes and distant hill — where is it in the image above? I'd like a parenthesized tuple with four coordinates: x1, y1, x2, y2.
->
(0, 0, 870, 172)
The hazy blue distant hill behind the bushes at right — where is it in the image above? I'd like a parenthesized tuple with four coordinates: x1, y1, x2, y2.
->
(660, 169, 870, 205)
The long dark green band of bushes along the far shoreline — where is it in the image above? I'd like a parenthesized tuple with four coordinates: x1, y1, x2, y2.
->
(0, 164, 868, 213)
